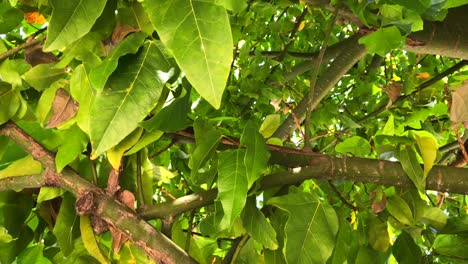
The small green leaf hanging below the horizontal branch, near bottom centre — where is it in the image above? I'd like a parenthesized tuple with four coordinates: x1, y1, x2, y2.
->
(241, 199, 278, 250)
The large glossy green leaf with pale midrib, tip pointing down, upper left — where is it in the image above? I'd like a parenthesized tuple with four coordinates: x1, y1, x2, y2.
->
(90, 42, 172, 158)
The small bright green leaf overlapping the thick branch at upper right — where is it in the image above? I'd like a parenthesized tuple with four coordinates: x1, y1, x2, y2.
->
(359, 26, 405, 57)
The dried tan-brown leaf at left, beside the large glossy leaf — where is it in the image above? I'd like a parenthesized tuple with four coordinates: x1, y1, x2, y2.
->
(46, 88, 79, 128)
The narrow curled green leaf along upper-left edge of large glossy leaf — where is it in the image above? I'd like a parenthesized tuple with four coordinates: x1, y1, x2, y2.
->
(89, 32, 146, 91)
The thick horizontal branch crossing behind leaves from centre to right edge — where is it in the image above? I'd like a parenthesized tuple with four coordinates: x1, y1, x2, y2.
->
(140, 135, 468, 219)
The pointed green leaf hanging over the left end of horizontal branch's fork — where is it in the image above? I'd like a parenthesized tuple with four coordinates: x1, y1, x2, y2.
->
(241, 122, 270, 188)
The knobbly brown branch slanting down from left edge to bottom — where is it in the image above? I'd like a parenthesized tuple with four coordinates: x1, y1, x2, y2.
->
(0, 122, 194, 263)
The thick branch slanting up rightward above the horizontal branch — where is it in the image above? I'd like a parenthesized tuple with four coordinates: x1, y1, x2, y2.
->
(273, 35, 366, 140)
